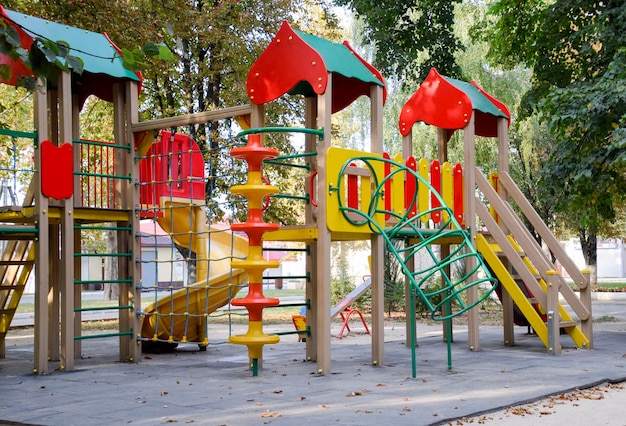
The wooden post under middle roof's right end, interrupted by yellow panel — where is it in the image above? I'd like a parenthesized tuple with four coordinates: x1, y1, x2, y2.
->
(368, 85, 385, 365)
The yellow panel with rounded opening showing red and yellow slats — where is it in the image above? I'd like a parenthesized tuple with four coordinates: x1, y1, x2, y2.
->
(318, 147, 385, 234)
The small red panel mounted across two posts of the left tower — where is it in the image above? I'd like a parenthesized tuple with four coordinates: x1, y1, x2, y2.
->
(39, 141, 74, 200)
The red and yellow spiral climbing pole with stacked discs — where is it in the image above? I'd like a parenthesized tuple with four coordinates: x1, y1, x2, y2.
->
(228, 134, 280, 376)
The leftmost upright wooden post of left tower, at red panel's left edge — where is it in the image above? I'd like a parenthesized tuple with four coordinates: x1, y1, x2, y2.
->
(33, 81, 50, 374)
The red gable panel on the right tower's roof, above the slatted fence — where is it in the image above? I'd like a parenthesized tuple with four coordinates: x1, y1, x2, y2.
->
(398, 68, 472, 136)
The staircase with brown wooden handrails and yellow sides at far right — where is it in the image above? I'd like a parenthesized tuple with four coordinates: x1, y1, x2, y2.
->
(475, 172, 592, 354)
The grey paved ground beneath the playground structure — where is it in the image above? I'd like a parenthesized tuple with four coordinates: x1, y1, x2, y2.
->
(0, 301, 626, 425)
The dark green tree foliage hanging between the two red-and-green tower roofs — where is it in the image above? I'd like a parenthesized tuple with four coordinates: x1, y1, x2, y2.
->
(337, 0, 463, 82)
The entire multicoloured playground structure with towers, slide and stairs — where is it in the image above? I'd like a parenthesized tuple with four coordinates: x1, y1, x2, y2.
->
(0, 10, 592, 376)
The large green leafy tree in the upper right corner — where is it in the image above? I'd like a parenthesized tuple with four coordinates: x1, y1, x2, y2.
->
(482, 0, 626, 280)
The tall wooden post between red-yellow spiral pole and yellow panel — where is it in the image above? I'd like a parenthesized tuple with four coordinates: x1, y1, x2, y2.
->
(313, 73, 333, 374)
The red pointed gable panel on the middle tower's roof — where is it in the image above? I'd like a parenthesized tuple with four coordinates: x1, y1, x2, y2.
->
(247, 21, 328, 105)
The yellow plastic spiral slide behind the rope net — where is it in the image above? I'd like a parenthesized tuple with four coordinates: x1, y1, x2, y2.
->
(141, 203, 248, 346)
